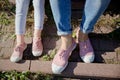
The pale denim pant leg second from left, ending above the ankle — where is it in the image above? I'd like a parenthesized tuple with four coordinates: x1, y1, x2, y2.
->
(33, 0, 45, 30)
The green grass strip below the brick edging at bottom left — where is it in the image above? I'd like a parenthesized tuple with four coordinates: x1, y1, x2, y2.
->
(0, 71, 53, 80)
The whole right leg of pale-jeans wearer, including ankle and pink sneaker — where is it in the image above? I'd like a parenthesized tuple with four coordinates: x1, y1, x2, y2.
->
(32, 0, 45, 56)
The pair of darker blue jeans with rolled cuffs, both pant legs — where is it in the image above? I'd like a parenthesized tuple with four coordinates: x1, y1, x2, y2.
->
(50, 0, 110, 35)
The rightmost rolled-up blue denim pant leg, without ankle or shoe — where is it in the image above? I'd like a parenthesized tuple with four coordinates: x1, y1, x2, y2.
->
(80, 0, 110, 33)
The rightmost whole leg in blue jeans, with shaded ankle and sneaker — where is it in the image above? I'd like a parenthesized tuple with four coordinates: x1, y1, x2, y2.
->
(79, 0, 110, 63)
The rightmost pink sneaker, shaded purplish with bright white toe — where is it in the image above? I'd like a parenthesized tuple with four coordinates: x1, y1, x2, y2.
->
(79, 39, 95, 63)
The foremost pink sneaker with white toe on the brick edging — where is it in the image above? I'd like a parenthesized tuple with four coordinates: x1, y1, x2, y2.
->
(52, 41, 76, 74)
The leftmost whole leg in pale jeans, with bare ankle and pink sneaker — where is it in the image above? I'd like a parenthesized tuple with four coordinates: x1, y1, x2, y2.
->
(10, 0, 30, 62)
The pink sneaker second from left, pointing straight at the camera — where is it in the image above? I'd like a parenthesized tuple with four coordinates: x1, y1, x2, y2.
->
(32, 39, 43, 56)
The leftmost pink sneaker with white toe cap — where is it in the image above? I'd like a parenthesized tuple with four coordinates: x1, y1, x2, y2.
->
(10, 43, 27, 62)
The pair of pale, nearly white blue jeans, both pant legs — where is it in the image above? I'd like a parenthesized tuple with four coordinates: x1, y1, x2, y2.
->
(15, 0, 45, 34)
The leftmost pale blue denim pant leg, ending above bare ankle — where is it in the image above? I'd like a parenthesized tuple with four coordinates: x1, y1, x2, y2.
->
(15, 0, 30, 34)
